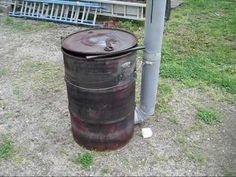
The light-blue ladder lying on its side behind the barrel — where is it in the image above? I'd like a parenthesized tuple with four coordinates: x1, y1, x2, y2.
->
(9, 0, 102, 26)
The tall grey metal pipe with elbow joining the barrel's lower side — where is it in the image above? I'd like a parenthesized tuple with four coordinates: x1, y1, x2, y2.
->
(135, 0, 166, 124)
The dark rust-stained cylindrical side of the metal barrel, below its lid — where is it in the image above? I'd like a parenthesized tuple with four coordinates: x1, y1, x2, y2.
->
(62, 29, 136, 151)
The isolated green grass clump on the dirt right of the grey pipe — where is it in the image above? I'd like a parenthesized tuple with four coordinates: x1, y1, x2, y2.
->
(197, 108, 222, 124)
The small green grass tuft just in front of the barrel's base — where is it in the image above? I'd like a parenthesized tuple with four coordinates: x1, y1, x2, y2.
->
(74, 152, 93, 169)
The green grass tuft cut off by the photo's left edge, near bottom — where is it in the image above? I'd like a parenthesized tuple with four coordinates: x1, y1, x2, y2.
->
(0, 134, 13, 158)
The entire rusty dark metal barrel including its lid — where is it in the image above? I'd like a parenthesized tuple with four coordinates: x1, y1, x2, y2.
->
(62, 29, 137, 151)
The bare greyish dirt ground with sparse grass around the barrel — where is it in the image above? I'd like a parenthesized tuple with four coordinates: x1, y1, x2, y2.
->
(0, 17, 236, 176)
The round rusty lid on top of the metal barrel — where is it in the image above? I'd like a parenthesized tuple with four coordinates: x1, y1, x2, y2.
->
(62, 28, 137, 55)
